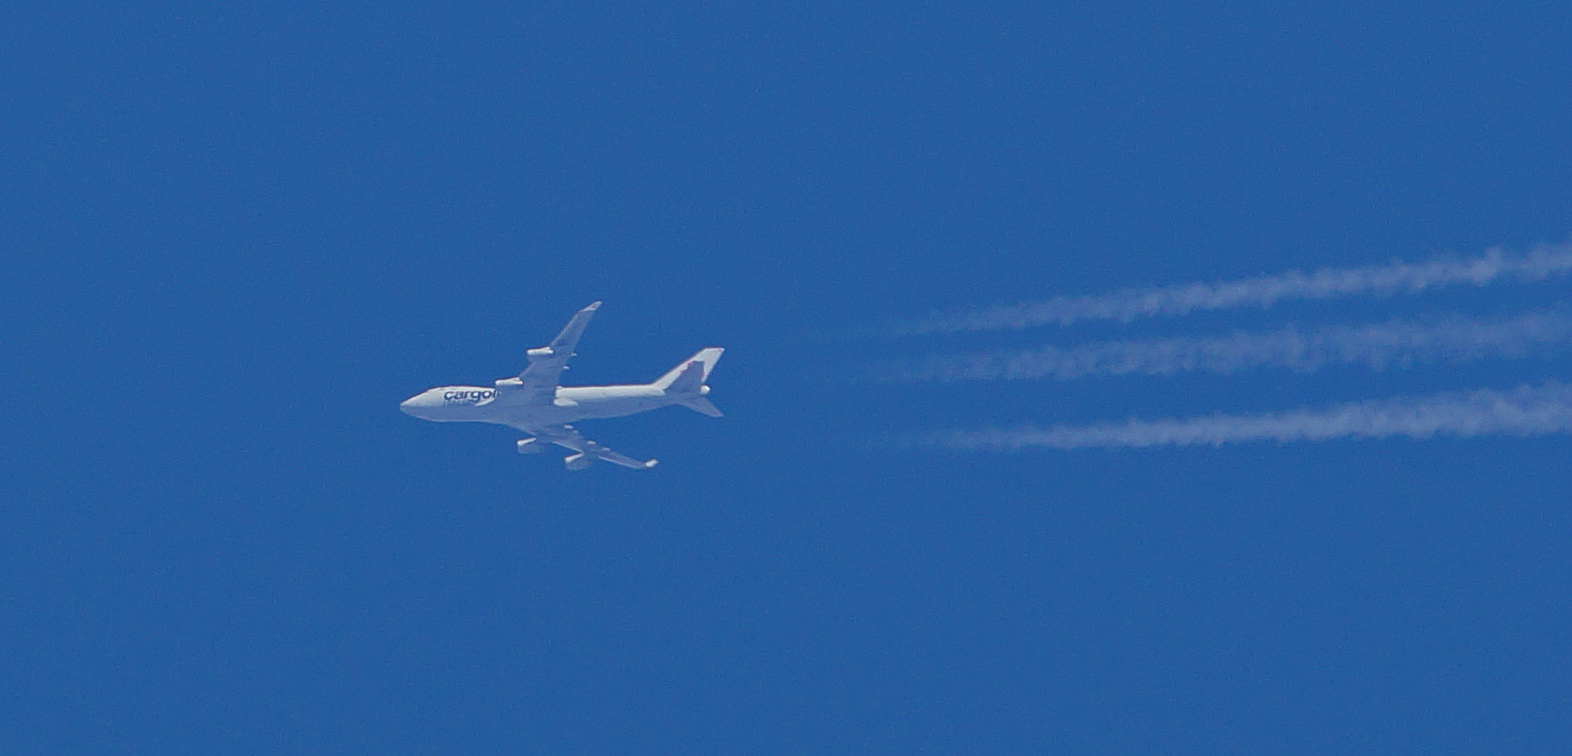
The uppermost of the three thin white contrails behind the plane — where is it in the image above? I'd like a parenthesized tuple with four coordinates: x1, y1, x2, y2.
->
(893, 244, 1572, 335)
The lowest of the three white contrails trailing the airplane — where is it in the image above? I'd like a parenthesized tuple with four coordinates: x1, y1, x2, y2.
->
(905, 382, 1572, 451)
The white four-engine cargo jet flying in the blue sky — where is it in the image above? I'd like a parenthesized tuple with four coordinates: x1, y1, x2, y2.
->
(399, 302, 723, 470)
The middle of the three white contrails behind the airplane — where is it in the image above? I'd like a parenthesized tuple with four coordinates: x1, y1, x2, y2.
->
(879, 310, 1572, 384)
